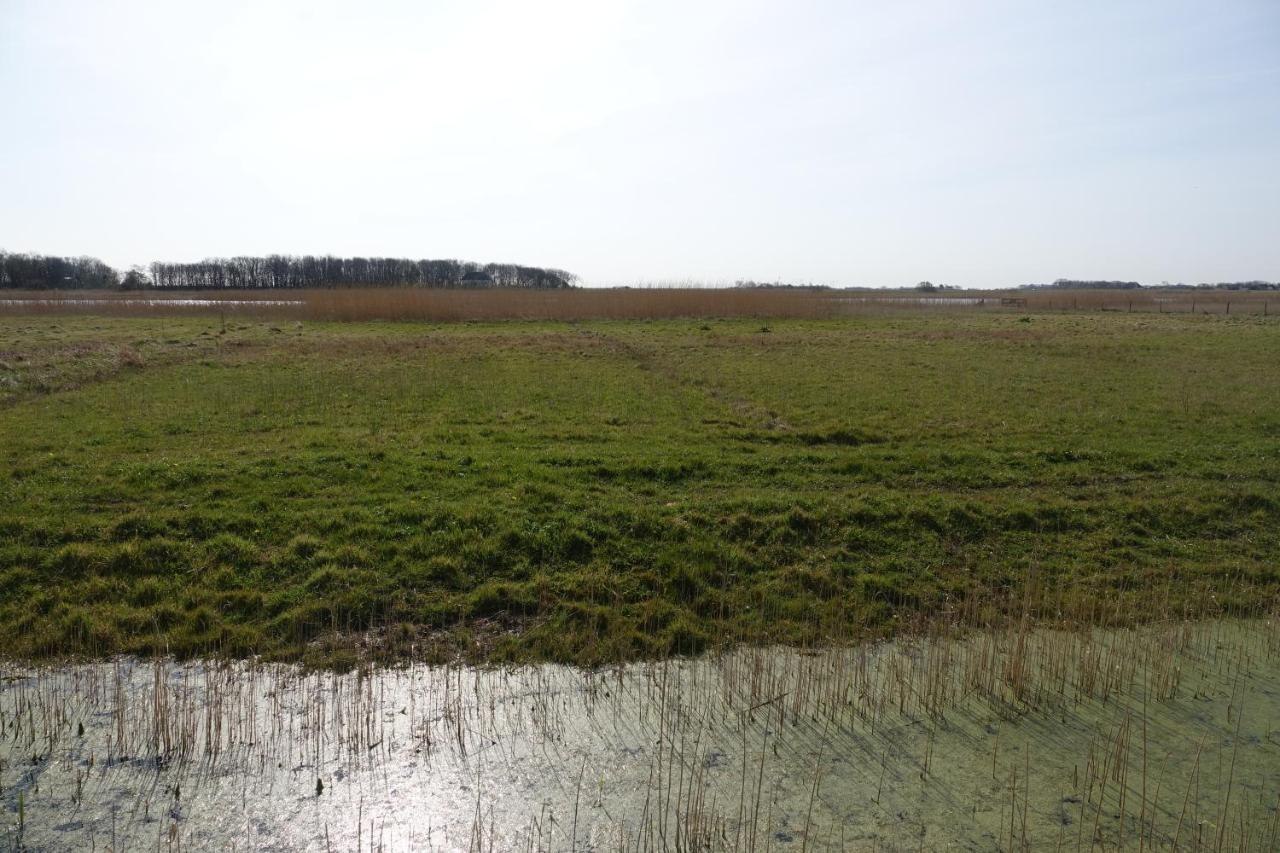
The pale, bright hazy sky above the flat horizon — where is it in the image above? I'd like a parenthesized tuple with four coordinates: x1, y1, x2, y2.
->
(0, 0, 1280, 287)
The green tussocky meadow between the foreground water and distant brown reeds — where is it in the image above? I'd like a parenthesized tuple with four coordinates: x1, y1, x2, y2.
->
(0, 314, 1280, 665)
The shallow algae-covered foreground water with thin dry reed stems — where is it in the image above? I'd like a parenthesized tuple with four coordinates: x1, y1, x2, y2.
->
(0, 620, 1280, 850)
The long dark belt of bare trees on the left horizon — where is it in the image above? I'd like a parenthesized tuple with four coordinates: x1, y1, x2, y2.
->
(0, 252, 577, 291)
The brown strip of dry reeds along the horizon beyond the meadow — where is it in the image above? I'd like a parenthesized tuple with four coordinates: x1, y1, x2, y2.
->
(0, 287, 1280, 323)
